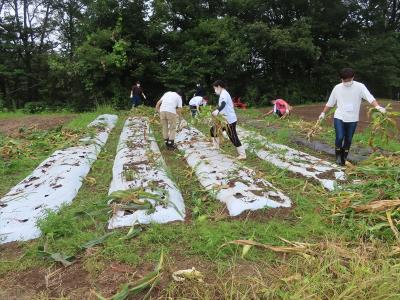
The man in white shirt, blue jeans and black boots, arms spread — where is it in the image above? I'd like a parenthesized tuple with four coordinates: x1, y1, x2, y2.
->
(318, 68, 386, 166)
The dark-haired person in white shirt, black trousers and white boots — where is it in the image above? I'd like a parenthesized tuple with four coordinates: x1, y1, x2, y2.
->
(210, 80, 246, 160)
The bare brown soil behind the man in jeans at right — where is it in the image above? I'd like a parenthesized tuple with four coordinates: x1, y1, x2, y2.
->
(276, 101, 400, 132)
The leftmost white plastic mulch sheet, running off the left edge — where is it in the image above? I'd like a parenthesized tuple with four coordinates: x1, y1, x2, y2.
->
(0, 115, 118, 243)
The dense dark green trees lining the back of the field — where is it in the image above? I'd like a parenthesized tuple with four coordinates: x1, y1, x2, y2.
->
(0, 0, 400, 111)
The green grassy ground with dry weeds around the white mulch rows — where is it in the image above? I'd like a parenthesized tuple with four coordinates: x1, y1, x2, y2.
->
(0, 108, 400, 299)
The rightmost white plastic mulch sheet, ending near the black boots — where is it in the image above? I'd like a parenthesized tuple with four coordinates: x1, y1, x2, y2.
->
(237, 127, 346, 190)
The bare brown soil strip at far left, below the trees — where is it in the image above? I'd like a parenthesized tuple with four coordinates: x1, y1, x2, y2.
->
(0, 115, 75, 136)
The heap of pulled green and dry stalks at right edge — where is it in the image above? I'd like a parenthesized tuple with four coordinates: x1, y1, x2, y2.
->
(323, 153, 400, 242)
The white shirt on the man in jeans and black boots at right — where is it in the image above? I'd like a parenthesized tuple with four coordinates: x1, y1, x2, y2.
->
(326, 81, 375, 122)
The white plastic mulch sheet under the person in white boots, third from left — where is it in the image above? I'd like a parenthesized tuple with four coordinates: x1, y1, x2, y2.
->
(175, 127, 291, 216)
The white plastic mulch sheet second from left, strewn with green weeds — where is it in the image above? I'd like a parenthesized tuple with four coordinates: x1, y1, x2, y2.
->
(108, 117, 185, 229)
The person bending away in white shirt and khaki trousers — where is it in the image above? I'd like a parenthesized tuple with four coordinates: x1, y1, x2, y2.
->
(156, 92, 182, 149)
